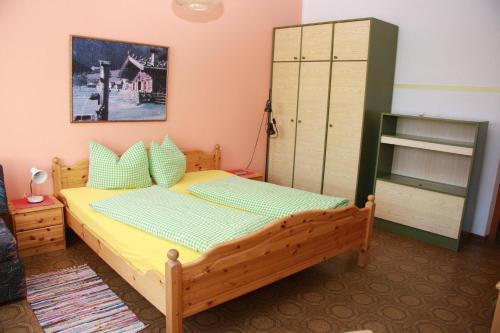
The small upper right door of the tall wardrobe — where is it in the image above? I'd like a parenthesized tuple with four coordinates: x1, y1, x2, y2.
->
(333, 20, 370, 60)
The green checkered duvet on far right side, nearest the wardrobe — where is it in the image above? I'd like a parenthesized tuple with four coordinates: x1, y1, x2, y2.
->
(189, 176, 348, 219)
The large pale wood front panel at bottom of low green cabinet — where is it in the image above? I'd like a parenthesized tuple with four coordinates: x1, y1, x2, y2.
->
(375, 180, 465, 239)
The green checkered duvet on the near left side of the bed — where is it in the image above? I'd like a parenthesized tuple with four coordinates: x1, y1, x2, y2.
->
(90, 186, 273, 252)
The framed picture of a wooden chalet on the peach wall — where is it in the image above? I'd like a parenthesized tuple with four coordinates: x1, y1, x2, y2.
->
(71, 36, 168, 123)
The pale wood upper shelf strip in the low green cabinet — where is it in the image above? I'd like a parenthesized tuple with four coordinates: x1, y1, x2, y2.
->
(380, 134, 474, 156)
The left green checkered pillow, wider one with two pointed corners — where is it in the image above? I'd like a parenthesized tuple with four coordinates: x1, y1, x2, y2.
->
(87, 141, 152, 190)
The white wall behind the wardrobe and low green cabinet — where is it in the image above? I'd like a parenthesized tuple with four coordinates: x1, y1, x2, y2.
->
(302, 0, 500, 236)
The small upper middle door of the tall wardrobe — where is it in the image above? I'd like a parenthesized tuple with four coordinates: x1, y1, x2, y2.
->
(301, 23, 333, 61)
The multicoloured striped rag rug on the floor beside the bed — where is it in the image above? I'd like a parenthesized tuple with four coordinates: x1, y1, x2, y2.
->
(26, 265, 146, 333)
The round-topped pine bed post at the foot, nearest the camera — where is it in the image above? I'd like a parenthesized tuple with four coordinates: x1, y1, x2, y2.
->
(165, 249, 182, 333)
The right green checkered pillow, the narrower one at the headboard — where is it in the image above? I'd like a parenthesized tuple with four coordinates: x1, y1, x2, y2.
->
(149, 136, 186, 187)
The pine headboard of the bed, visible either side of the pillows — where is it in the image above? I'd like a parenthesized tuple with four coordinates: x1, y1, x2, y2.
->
(52, 145, 221, 197)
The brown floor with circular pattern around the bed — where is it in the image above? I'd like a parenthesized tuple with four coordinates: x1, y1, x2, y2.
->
(0, 230, 500, 333)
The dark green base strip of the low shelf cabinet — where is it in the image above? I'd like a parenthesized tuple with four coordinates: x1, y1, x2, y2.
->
(375, 218, 459, 251)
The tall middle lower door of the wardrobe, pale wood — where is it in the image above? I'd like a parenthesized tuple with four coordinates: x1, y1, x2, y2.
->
(293, 62, 331, 193)
